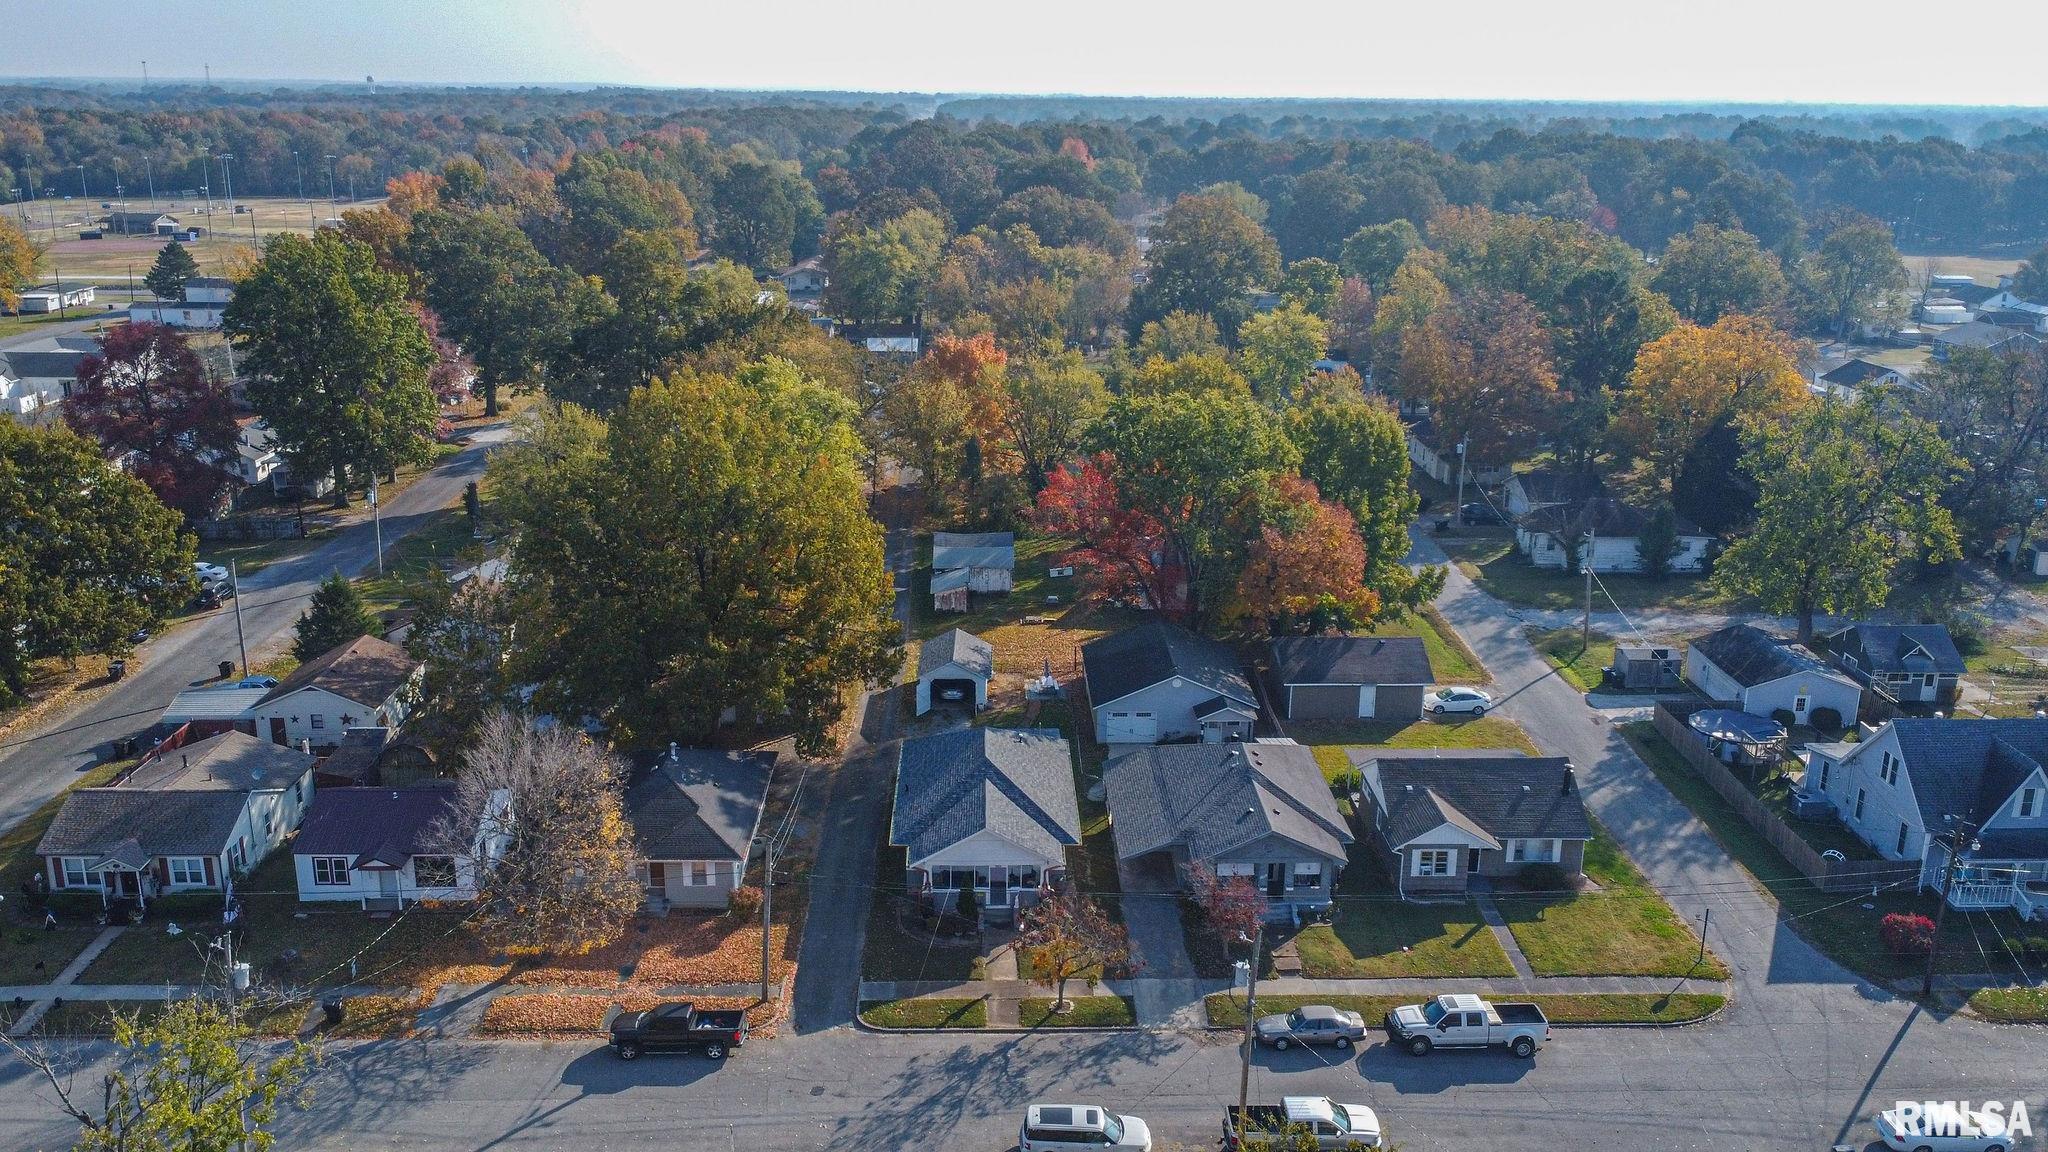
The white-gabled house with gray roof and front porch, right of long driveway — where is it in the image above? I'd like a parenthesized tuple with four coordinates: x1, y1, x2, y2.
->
(889, 728, 1081, 920)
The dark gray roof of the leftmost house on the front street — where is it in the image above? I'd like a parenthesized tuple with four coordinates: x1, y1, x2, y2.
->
(35, 787, 248, 857)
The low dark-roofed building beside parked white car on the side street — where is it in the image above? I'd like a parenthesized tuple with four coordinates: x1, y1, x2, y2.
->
(1272, 635, 1436, 719)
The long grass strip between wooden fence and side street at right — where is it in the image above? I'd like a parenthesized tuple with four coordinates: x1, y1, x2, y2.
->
(1620, 719, 2030, 982)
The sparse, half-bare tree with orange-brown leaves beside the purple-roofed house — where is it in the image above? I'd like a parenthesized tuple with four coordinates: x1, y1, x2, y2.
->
(428, 713, 643, 953)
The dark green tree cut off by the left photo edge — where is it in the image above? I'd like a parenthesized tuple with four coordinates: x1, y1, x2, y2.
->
(0, 420, 199, 699)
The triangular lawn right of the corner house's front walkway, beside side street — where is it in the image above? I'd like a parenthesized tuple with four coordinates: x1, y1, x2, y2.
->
(1495, 824, 1729, 980)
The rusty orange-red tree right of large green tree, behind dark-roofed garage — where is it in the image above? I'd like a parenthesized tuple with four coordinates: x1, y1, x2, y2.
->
(1233, 476, 1380, 635)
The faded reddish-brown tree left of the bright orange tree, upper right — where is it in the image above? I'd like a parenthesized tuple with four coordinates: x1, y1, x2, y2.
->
(1382, 291, 1559, 463)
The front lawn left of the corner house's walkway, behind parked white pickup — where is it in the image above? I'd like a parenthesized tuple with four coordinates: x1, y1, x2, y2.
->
(1294, 863, 1516, 980)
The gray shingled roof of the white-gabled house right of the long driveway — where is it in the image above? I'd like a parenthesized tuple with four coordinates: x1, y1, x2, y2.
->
(889, 728, 1081, 865)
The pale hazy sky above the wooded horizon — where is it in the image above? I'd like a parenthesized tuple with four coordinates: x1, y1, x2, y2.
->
(0, 0, 2048, 107)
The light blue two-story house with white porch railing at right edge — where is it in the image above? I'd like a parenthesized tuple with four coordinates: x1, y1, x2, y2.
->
(1804, 717, 2048, 918)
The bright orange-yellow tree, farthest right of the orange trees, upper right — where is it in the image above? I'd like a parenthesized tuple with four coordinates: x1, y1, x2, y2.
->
(1614, 316, 1812, 486)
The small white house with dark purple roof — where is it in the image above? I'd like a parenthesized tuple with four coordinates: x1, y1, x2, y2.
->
(291, 783, 504, 912)
